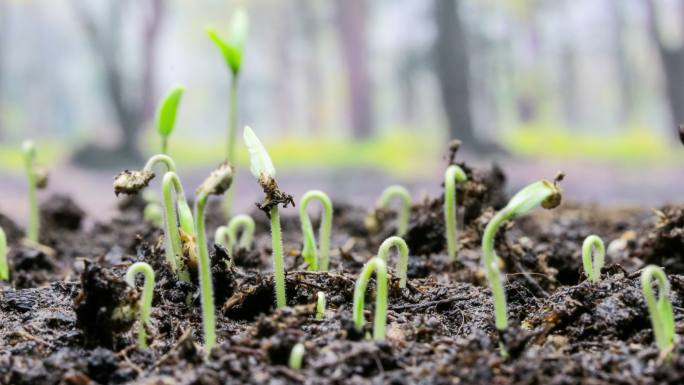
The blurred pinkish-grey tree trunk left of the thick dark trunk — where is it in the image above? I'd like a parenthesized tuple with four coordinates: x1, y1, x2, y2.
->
(336, 0, 373, 139)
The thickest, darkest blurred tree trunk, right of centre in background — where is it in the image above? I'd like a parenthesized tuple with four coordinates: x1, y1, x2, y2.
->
(433, 0, 486, 151)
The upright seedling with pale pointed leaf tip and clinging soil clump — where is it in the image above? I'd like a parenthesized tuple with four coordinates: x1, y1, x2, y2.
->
(243, 126, 294, 309)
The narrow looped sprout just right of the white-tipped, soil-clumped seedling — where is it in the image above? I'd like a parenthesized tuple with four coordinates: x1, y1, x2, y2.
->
(299, 190, 333, 271)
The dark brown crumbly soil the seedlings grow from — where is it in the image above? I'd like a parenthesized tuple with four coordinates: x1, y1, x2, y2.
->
(0, 165, 684, 385)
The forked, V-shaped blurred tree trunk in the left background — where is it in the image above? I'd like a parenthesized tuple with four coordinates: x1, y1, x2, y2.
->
(71, 0, 164, 165)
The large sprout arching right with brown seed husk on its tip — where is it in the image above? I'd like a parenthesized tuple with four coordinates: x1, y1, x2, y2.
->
(482, 174, 563, 331)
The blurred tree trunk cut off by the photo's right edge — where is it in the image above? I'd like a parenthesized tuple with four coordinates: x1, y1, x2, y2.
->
(645, 0, 684, 128)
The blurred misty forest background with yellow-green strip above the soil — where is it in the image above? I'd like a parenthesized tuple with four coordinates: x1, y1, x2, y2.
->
(0, 0, 684, 222)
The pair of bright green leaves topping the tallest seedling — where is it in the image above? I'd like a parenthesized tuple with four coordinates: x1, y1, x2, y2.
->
(206, 8, 249, 75)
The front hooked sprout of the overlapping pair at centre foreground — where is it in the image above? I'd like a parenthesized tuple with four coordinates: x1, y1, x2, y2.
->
(353, 257, 387, 340)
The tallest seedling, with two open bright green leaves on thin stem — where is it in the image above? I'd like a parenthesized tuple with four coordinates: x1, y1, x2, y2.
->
(206, 8, 249, 215)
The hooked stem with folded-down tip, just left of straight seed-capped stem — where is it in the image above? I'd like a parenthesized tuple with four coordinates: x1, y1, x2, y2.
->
(162, 171, 195, 282)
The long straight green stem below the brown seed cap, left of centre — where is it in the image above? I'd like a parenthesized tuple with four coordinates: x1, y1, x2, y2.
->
(195, 192, 216, 356)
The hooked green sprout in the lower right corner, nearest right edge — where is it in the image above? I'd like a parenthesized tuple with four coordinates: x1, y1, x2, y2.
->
(641, 265, 675, 353)
